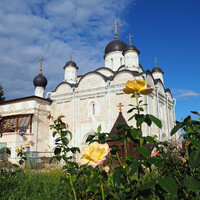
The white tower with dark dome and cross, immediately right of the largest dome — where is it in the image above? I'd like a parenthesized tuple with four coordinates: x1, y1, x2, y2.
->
(123, 33, 140, 71)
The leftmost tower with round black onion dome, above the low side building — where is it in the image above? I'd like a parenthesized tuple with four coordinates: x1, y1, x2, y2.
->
(33, 58, 47, 98)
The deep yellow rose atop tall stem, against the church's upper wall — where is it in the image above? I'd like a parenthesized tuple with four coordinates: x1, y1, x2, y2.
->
(123, 79, 153, 95)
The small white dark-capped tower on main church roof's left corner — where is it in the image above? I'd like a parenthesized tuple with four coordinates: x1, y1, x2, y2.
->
(63, 53, 78, 84)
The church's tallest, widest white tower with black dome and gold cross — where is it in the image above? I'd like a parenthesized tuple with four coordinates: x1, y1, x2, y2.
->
(104, 20, 127, 71)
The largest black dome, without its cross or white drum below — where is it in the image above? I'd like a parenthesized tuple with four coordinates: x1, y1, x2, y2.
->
(105, 40, 127, 55)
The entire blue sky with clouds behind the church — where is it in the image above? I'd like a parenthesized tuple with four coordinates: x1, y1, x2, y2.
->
(0, 0, 200, 120)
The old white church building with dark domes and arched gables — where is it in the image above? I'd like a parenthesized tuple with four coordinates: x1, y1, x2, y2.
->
(0, 29, 178, 164)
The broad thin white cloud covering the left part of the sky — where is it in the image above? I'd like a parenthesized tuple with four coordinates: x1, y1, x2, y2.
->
(0, 0, 136, 100)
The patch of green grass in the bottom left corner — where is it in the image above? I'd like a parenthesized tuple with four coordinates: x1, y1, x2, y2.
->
(0, 169, 69, 200)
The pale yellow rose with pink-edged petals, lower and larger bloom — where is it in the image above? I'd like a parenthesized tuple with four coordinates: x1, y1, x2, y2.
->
(78, 142, 110, 168)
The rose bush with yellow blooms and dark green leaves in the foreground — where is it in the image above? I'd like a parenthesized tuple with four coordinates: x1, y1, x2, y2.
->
(11, 79, 200, 200)
